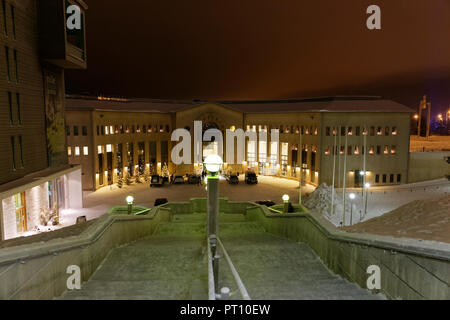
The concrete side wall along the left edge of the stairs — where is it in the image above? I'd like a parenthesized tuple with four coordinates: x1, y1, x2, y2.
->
(0, 208, 170, 300)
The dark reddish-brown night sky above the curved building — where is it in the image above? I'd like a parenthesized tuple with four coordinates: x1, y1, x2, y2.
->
(66, 0, 450, 114)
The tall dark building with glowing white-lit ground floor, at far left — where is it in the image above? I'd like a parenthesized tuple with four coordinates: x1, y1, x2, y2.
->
(0, 0, 87, 240)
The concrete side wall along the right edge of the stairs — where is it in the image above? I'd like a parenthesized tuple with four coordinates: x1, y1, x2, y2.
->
(247, 206, 450, 299)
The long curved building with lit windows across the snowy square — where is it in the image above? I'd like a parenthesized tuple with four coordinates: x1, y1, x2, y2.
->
(66, 96, 413, 190)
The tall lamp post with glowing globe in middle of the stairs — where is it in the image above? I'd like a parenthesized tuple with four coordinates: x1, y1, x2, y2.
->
(204, 154, 223, 238)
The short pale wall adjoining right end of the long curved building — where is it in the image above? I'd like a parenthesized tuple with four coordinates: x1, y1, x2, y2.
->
(408, 151, 450, 183)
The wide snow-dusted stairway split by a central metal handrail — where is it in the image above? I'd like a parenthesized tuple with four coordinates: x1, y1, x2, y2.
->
(62, 214, 379, 300)
